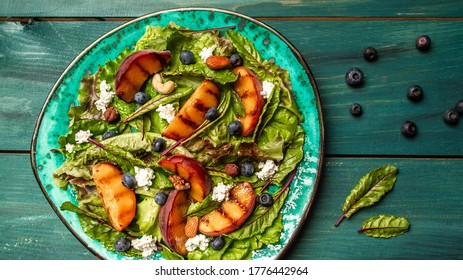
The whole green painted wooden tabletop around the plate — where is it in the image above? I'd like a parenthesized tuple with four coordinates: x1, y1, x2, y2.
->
(0, 0, 463, 260)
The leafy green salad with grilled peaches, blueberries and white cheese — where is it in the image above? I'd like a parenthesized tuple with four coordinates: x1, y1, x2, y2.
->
(53, 23, 305, 260)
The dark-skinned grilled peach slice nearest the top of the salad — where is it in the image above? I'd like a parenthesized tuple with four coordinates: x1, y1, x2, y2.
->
(114, 50, 170, 102)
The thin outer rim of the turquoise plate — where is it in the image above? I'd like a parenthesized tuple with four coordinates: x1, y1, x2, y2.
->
(30, 7, 325, 260)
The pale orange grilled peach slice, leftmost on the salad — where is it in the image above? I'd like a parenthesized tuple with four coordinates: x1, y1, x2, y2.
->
(92, 162, 137, 231)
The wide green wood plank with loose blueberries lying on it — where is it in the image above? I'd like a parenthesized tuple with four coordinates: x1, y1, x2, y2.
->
(0, 20, 463, 156)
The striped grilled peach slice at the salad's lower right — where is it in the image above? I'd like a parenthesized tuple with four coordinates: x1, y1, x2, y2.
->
(198, 182, 257, 236)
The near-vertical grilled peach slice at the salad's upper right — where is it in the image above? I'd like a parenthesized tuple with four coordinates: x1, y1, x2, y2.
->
(233, 66, 265, 136)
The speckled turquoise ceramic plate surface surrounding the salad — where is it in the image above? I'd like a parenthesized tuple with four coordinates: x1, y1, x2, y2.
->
(31, 8, 323, 259)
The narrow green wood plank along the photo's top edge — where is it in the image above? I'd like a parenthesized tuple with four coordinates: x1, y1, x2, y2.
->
(0, 0, 463, 17)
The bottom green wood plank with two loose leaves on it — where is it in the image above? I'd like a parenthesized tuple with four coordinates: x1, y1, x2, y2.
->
(0, 154, 463, 260)
